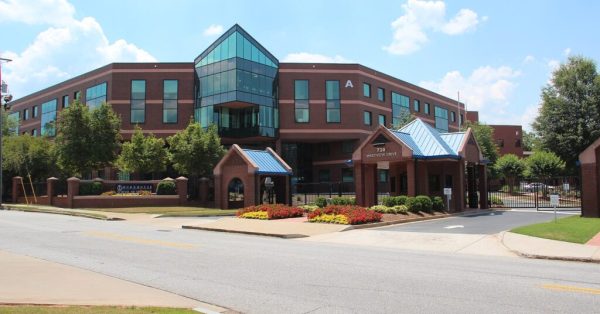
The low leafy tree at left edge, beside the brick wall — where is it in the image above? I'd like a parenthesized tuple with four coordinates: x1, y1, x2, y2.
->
(2, 134, 56, 179)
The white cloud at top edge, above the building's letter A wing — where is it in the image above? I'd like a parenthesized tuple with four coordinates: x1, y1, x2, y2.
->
(383, 0, 487, 55)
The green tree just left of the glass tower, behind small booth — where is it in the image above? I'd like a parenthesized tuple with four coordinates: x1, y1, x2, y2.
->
(167, 121, 225, 176)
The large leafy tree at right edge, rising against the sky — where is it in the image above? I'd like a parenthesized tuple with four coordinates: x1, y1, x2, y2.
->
(533, 56, 600, 170)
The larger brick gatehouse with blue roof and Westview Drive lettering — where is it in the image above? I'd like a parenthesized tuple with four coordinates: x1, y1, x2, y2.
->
(352, 119, 488, 211)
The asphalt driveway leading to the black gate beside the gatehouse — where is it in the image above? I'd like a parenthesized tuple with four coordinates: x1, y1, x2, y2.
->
(377, 211, 566, 234)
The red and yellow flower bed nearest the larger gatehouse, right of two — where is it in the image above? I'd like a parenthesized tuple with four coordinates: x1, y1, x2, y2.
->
(308, 205, 382, 225)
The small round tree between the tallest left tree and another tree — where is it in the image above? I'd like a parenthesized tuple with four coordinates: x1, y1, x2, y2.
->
(117, 126, 167, 173)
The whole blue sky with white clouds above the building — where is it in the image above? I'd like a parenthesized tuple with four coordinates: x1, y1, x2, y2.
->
(0, 0, 600, 127)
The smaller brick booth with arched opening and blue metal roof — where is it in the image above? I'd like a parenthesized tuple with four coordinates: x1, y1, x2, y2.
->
(213, 144, 292, 209)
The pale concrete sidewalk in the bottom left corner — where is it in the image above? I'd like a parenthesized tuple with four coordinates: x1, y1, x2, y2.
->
(0, 251, 226, 313)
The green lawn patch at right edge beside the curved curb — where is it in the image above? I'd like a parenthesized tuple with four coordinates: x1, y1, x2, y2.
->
(511, 216, 600, 243)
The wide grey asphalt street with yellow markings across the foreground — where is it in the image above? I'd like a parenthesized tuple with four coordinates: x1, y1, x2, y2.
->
(0, 211, 600, 313)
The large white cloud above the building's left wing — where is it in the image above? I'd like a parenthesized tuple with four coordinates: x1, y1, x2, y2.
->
(0, 0, 156, 98)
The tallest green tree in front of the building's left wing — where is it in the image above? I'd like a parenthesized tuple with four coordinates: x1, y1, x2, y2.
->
(55, 99, 120, 175)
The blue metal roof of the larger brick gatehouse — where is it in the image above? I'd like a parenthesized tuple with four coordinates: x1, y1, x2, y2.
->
(390, 119, 465, 159)
